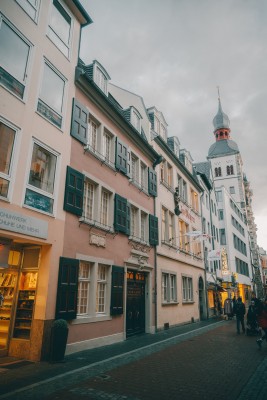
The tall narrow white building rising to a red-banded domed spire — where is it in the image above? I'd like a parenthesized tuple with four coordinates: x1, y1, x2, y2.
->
(208, 97, 253, 301)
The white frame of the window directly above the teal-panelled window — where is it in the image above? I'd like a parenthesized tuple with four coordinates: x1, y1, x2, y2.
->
(37, 59, 67, 130)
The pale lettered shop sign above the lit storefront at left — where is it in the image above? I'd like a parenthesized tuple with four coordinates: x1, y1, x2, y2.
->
(0, 208, 48, 239)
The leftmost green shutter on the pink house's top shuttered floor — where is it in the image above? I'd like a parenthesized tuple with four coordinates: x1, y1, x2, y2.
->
(70, 98, 89, 144)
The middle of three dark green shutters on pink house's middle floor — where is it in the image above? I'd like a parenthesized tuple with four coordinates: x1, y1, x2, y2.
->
(114, 194, 130, 235)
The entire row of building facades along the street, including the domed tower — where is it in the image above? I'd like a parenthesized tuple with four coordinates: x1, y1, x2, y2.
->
(0, 0, 266, 360)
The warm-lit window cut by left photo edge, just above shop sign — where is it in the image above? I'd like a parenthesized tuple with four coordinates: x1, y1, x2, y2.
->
(0, 120, 16, 198)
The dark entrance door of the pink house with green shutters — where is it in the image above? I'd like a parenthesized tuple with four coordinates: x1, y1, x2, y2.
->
(126, 271, 145, 337)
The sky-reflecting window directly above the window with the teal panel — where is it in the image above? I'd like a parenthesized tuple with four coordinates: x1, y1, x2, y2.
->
(37, 62, 66, 128)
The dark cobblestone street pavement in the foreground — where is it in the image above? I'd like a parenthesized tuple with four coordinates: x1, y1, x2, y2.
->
(0, 321, 267, 400)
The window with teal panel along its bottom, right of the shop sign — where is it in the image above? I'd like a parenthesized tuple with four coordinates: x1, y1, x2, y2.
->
(24, 143, 57, 214)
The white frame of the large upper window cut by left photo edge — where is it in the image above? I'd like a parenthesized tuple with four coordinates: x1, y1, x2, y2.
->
(0, 13, 33, 100)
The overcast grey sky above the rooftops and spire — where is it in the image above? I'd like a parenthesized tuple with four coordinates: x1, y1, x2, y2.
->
(80, 0, 267, 250)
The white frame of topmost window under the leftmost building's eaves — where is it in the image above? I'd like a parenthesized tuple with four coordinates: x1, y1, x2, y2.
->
(47, 0, 73, 59)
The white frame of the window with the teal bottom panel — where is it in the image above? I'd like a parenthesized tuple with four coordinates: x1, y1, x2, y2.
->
(23, 138, 60, 215)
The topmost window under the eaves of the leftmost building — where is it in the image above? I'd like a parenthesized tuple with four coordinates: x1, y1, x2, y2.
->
(48, 0, 71, 57)
